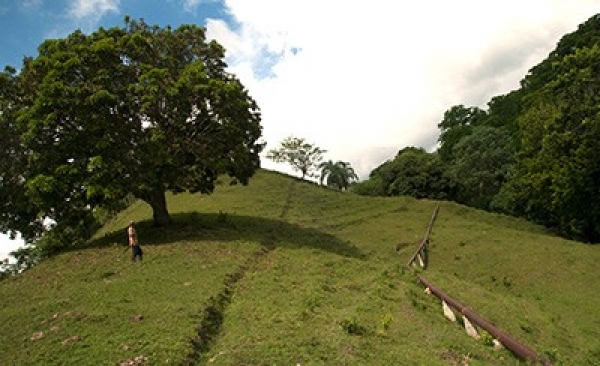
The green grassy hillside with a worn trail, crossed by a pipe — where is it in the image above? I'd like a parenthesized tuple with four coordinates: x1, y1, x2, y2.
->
(0, 170, 600, 365)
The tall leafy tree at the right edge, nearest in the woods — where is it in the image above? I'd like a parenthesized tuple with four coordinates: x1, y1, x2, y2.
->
(505, 45, 600, 242)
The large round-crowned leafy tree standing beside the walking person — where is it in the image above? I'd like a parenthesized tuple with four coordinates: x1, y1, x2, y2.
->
(0, 18, 263, 243)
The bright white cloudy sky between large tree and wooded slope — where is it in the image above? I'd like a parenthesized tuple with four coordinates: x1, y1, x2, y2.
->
(207, 0, 600, 177)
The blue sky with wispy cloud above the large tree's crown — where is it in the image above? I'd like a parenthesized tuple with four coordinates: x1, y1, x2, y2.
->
(0, 0, 231, 68)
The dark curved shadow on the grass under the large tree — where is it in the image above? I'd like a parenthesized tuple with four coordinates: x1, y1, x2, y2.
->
(86, 212, 365, 259)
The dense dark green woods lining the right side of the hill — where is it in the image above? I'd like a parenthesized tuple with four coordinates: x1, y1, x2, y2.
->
(354, 15, 600, 243)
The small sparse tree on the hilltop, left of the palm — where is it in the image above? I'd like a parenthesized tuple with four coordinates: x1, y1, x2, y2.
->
(267, 136, 327, 179)
